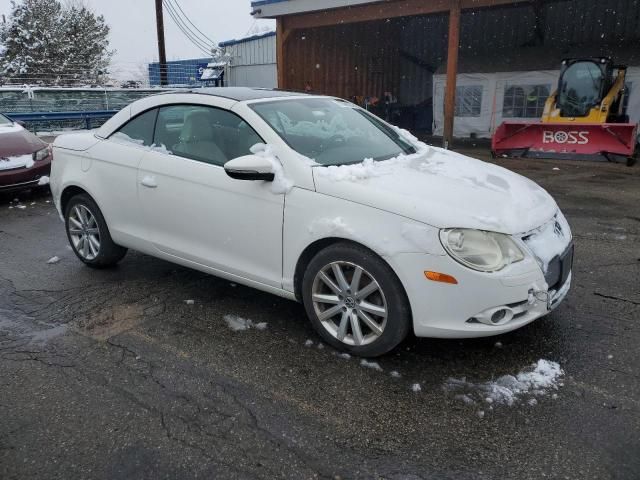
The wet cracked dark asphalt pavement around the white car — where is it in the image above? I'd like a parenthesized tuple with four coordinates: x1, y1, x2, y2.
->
(0, 156, 640, 480)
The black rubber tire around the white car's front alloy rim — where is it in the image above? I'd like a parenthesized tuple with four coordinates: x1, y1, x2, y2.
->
(302, 242, 411, 357)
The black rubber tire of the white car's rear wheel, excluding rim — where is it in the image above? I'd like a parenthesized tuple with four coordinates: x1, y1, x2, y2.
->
(64, 193, 127, 268)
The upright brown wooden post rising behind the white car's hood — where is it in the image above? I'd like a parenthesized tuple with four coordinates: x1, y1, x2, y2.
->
(442, 0, 462, 148)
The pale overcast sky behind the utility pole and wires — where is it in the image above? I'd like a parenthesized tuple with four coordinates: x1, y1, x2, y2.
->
(0, 0, 275, 72)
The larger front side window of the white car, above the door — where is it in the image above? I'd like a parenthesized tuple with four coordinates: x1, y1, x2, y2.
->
(153, 105, 262, 166)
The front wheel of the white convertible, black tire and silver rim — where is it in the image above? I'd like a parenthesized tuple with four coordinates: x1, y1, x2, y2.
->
(302, 243, 411, 357)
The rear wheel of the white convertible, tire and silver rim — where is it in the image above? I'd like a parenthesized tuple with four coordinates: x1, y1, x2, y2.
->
(65, 194, 127, 268)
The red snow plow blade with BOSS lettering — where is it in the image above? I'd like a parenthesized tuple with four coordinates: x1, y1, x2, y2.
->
(491, 122, 638, 161)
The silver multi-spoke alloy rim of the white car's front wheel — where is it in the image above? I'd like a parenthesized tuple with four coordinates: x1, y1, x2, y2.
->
(311, 261, 388, 346)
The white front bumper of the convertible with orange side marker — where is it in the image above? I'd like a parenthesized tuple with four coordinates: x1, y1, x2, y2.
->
(390, 249, 571, 338)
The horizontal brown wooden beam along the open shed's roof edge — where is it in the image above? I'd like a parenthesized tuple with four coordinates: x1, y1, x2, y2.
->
(278, 0, 532, 29)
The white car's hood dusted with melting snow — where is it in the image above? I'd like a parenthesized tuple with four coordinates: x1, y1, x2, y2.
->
(313, 144, 558, 234)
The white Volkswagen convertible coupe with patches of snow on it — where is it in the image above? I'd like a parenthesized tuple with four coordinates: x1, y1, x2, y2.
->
(51, 88, 573, 356)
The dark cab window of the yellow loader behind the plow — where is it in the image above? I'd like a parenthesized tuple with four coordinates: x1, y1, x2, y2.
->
(558, 62, 605, 117)
